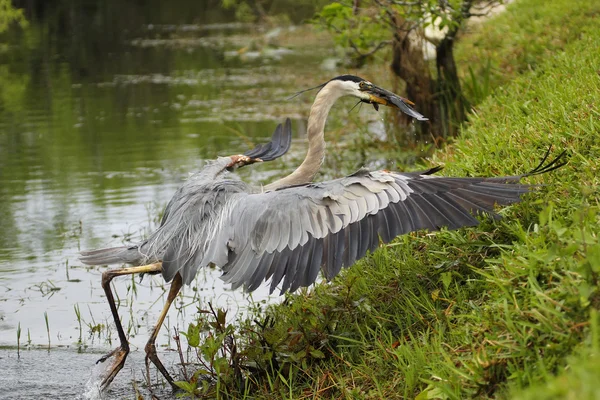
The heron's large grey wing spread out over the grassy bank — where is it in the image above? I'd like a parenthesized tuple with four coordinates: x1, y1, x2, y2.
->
(205, 150, 568, 292)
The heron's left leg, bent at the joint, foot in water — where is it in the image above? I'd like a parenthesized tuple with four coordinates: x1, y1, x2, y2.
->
(96, 263, 162, 390)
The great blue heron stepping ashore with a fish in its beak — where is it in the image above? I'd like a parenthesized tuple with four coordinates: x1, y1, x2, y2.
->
(81, 75, 564, 387)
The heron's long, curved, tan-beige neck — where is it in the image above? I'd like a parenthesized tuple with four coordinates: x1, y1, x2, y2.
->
(265, 86, 342, 190)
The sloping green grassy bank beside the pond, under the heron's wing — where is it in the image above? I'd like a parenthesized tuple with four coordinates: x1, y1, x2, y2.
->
(178, 0, 600, 399)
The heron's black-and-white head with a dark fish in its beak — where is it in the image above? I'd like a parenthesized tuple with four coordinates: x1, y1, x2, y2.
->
(321, 75, 428, 121)
